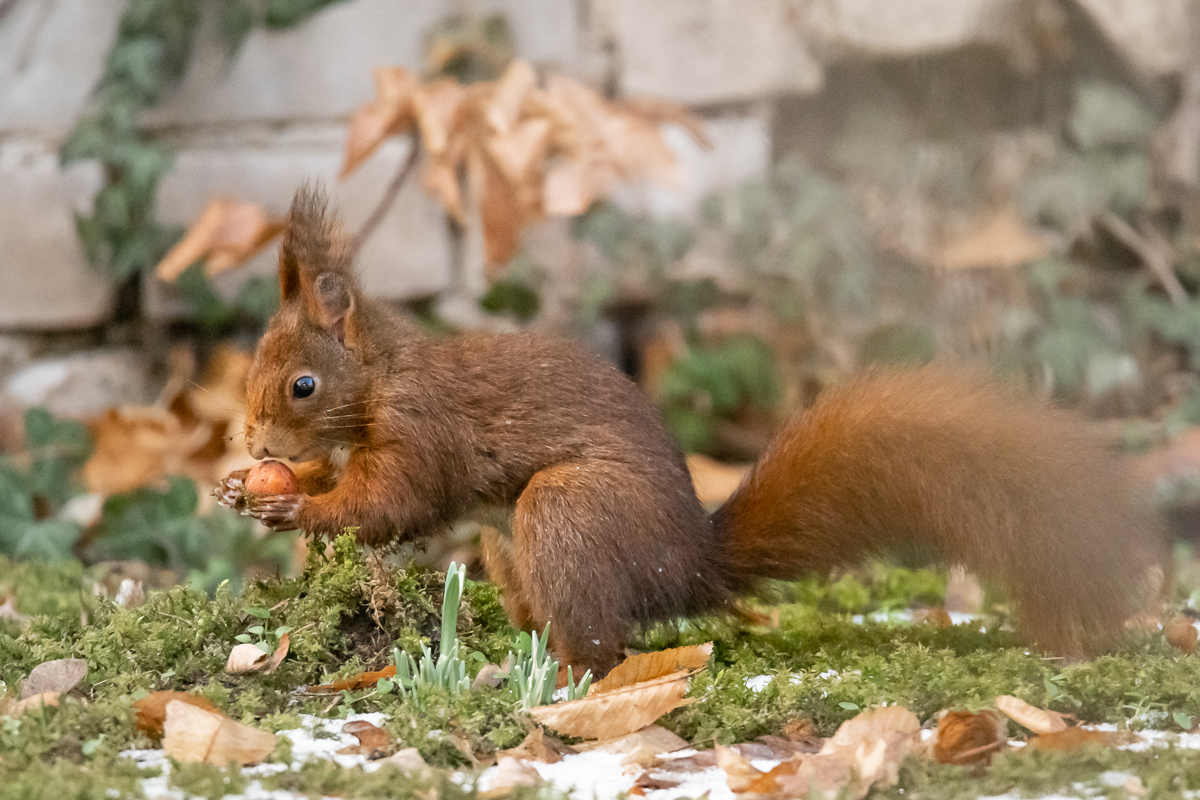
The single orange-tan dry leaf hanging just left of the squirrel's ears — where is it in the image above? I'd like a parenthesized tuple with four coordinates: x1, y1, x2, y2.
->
(155, 197, 283, 282)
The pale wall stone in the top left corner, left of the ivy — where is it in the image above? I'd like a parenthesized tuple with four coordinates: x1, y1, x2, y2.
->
(0, 0, 126, 139)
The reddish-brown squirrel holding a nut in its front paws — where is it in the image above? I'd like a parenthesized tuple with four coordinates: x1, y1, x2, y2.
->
(216, 190, 1165, 674)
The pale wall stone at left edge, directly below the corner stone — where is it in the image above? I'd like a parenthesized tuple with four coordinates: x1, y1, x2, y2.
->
(0, 139, 113, 330)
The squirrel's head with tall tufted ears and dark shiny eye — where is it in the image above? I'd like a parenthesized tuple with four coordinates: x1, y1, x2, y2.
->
(246, 187, 367, 462)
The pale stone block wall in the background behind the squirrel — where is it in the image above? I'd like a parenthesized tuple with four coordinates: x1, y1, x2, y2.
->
(0, 0, 1198, 331)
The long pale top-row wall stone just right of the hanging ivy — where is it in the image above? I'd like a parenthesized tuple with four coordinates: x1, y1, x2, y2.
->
(146, 0, 578, 126)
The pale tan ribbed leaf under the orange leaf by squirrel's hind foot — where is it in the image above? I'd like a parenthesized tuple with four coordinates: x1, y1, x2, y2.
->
(529, 672, 690, 739)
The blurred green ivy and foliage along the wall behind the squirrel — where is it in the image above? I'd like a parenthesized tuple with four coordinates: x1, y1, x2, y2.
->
(7, 0, 1200, 590)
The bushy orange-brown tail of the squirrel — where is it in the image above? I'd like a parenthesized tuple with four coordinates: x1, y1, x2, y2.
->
(714, 366, 1166, 656)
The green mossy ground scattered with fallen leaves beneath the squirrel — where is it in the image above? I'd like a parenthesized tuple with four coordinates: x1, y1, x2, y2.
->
(0, 537, 1200, 799)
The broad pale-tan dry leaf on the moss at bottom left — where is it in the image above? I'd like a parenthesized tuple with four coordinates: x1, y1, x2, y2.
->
(162, 700, 276, 766)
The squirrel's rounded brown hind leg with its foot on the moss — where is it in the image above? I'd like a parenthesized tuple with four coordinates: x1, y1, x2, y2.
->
(510, 459, 708, 678)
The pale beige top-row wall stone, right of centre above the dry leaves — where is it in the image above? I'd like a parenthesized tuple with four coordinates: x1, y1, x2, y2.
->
(594, 0, 822, 104)
